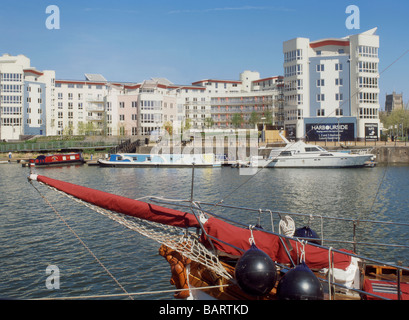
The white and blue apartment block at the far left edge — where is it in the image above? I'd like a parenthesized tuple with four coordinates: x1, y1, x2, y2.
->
(0, 54, 55, 140)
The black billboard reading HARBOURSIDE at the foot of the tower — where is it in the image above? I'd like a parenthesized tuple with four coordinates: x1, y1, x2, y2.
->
(305, 123, 355, 141)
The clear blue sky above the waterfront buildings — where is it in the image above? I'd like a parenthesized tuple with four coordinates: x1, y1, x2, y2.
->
(0, 0, 409, 106)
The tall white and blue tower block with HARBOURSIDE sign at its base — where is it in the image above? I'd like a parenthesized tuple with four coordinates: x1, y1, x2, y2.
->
(283, 28, 380, 141)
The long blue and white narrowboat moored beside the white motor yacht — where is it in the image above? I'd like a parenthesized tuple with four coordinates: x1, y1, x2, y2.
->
(98, 153, 222, 167)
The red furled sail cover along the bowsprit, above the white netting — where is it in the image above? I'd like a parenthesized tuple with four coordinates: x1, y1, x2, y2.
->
(37, 175, 199, 228)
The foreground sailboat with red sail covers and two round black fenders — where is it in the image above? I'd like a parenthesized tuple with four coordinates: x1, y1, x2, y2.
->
(28, 174, 409, 300)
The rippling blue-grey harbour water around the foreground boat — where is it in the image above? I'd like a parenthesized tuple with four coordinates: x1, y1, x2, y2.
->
(0, 164, 409, 300)
